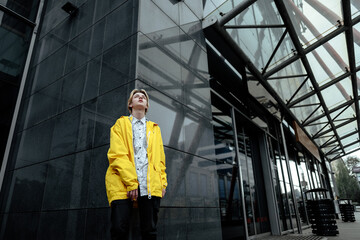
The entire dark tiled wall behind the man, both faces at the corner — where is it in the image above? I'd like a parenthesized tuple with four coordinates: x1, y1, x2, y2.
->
(0, 0, 221, 239)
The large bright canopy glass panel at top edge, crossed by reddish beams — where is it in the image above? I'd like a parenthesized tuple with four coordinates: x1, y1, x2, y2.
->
(284, 0, 343, 47)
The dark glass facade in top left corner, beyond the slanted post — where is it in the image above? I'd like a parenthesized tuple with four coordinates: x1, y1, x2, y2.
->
(0, 1, 38, 169)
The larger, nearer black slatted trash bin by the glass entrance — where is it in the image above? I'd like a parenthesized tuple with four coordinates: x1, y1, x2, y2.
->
(305, 188, 339, 236)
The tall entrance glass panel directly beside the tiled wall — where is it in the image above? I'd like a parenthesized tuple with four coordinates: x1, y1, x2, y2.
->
(211, 94, 245, 239)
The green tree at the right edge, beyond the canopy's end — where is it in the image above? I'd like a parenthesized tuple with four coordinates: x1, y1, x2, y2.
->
(335, 160, 360, 202)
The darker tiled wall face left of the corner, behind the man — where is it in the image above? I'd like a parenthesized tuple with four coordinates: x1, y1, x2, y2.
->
(0, 0, 138, 239)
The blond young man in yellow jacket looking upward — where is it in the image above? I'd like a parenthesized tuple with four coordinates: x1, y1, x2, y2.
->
(105, 89, 167, 240)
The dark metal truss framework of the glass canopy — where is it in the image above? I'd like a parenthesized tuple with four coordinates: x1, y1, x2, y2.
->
(203, 0, 360, 161)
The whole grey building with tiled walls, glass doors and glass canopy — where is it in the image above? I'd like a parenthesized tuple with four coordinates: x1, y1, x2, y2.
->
(0, 0, 360, 239)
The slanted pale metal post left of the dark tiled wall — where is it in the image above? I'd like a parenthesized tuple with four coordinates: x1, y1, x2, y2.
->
(0, 0, 45, 191)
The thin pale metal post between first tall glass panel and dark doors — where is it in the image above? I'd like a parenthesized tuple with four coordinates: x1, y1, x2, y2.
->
(231, 107, 249, 239)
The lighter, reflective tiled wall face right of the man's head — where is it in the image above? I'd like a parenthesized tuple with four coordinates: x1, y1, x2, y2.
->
(136, 0, 221, 239)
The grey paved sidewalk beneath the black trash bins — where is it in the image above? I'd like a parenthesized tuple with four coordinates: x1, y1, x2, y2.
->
(256, 212, 360, 240)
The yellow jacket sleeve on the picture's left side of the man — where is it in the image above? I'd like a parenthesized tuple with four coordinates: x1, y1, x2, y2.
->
(108, 120, 139, 191)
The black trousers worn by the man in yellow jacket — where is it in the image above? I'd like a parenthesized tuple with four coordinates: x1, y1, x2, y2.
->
(110, 196, 160, 240)
